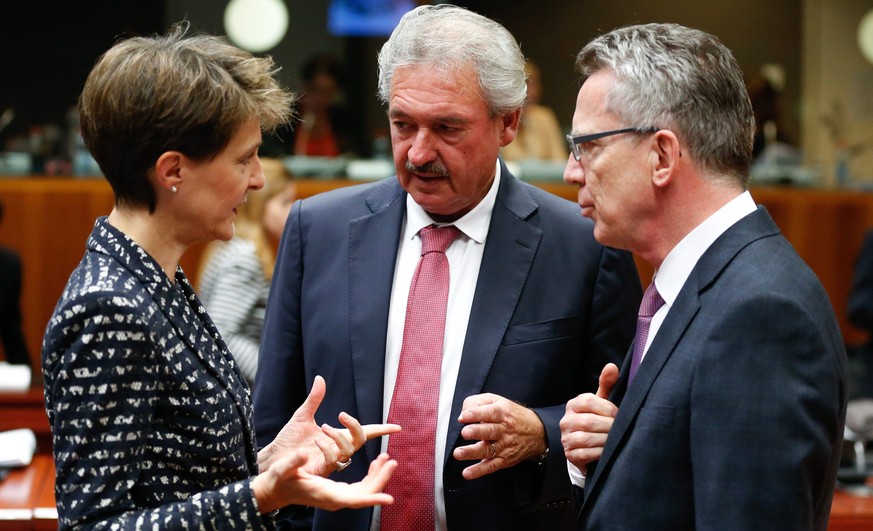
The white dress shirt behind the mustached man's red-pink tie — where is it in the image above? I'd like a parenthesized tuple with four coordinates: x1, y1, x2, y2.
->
(370, 162, 500, 531)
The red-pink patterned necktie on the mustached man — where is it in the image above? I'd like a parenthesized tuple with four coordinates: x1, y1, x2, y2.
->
(381, 225, 460, 531)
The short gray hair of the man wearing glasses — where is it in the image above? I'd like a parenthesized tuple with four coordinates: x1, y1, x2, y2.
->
(576, 24, 755, 188)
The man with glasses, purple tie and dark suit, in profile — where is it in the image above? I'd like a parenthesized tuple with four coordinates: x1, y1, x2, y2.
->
(561, 24, 846, 530)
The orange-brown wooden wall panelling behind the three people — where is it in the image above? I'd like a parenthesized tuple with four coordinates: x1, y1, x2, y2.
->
(0, 177, 873, 381)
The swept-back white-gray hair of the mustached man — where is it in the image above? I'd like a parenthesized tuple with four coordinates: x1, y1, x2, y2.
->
(379, 4, 527, 116)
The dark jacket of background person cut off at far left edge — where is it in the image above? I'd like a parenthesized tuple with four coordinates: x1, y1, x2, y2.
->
(0, 247, 30, 366)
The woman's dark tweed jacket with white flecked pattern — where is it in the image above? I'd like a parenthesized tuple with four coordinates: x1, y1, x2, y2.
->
(42, 218, 272, 529)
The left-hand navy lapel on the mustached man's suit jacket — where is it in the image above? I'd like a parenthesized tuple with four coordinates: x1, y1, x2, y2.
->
(348, 180, 406, 459)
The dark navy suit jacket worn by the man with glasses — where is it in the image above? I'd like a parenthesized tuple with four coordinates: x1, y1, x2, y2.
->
(579, 207, 846, 531)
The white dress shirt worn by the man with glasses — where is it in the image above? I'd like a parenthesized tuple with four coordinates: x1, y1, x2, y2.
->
(567, 191, 757, 487)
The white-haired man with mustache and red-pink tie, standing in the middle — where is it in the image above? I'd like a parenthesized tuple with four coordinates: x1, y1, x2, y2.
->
(255, 5, 641, 531)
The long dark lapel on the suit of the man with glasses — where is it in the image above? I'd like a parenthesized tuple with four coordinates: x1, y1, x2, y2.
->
(583, 207, 779, 507)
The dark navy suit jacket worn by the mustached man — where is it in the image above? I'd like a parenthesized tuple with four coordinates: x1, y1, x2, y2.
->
(254, 166, 641, 531)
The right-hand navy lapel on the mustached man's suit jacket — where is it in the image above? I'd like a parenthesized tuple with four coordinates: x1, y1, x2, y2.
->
(445, 166, 542, 459)
